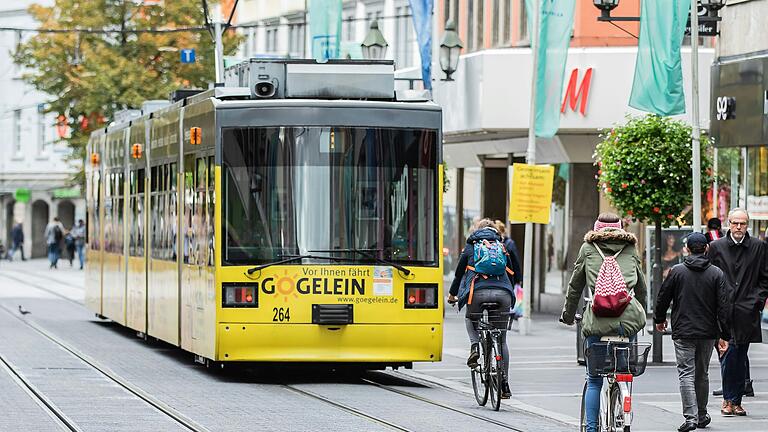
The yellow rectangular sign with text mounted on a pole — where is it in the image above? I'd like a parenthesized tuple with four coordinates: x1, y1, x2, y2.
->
(509, 164, 555, 224)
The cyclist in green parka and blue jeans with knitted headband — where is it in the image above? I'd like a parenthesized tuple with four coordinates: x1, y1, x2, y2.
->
(560, 213, 647, 432)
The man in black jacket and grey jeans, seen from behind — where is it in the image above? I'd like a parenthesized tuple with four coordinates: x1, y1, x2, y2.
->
(653, 232, 730, 432)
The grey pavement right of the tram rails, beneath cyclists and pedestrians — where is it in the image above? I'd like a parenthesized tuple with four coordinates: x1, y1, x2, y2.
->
(413, 284, 768, 432)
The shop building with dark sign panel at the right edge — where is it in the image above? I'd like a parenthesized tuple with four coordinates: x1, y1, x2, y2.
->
(709, 0, 768, 335)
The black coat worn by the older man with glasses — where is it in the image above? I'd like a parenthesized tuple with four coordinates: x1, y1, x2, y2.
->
(708, 231, 768, 343)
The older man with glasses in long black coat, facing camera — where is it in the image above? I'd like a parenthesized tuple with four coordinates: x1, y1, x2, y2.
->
(708, 208, 768, 417)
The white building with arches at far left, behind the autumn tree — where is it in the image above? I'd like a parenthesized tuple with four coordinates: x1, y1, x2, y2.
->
(0, 0, 85, 257)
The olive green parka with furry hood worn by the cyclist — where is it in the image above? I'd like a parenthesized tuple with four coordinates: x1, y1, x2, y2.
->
(562, 228, 648, 336)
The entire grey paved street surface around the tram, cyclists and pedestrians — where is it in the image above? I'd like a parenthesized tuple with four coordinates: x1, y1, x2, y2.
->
(0, 261, 768, 432)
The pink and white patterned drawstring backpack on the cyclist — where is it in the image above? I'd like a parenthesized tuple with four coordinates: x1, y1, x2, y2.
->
(592, 244, 632, 318)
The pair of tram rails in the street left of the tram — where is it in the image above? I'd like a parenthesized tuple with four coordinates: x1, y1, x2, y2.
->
(0, 305, 210, 432)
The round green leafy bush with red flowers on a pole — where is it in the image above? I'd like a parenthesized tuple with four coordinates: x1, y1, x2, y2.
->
(595, 115, 712, 227)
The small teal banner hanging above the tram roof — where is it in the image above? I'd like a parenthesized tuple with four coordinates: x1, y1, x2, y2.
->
(309, 0, 342, 62)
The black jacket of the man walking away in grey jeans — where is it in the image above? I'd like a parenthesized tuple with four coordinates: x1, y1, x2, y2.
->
(653, 254, 731, 340)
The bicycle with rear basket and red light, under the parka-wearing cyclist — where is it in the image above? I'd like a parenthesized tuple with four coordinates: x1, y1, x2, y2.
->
(579, 330, 651, 432)
